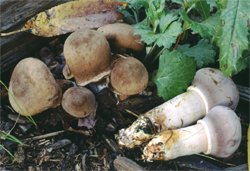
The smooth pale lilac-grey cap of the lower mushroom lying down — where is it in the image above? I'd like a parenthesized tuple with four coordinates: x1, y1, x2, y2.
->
(197, 106, 241, 157)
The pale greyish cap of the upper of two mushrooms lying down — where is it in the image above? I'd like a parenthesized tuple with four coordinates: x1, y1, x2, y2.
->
(190, 68, 239, 109)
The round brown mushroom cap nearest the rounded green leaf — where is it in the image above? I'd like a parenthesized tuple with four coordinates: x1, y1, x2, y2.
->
(110, 57, 148, 95)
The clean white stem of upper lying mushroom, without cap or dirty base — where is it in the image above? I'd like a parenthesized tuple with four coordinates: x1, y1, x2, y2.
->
(144, 86, 208, 130)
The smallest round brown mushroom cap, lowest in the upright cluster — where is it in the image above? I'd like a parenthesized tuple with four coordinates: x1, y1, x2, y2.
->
(62, 87, 97, 118)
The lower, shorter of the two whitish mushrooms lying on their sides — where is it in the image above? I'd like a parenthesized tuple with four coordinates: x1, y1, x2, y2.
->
(143, 106, 241, 161)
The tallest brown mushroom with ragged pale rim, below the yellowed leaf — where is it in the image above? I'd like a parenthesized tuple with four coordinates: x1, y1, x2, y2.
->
(63, 30, 111, 86)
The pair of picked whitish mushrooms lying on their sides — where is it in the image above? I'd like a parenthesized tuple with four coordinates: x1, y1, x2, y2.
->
(117, 68, 241, 160)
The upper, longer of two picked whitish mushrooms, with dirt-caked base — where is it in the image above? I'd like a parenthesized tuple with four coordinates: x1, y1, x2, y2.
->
(117, 68, 239, 148)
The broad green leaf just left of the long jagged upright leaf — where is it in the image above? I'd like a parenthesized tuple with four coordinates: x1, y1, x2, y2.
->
(181, 11, 220, 39)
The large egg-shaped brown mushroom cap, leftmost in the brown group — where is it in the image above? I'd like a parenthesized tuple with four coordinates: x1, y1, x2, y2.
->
(9, 57, 62, 116)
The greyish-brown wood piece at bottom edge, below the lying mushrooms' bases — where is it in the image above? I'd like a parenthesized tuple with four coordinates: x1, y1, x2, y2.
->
(114, 156, 146, 171)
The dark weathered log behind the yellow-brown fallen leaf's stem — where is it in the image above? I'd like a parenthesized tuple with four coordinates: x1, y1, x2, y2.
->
(0, 0, 72, 73)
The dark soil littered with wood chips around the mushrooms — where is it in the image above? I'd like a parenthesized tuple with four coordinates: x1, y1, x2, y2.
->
(0, 39, 249, 171)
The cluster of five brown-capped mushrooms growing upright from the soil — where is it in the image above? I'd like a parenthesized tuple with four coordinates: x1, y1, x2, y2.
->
(9, 23, 148, 127)
